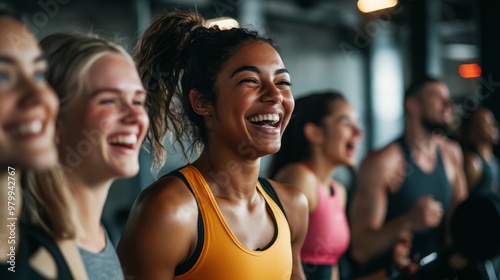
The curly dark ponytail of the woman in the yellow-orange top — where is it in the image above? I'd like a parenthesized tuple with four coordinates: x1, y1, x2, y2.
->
(133, 10, 205, 172)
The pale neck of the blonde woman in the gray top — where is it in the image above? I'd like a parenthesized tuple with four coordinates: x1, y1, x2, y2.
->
(66, 171, 112, 252)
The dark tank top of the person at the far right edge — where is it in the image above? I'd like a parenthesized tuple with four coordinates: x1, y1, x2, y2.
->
(472, 151, 500, 195)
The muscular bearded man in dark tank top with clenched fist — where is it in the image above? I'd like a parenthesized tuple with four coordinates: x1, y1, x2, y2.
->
(351, 78, 467, 279)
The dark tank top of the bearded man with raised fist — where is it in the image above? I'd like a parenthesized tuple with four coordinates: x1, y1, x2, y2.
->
(386, 137, 453, 258)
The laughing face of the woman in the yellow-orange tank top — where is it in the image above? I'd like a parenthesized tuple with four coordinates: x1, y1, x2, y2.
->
(207, 42, 294, 158)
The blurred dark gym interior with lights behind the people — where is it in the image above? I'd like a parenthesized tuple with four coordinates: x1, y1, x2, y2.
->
(0, 0, 500, 249)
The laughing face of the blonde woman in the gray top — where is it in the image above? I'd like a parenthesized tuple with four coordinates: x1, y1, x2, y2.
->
(58, 53, 149, 179)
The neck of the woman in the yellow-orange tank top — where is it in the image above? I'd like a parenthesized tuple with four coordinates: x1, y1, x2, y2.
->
(193, 148, 260, 200)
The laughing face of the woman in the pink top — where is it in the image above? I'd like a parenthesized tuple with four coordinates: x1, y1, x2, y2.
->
(319, 100, 362, 166)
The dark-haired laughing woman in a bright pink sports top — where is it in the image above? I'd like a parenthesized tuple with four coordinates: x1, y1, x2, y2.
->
(270, 91, 362, 280)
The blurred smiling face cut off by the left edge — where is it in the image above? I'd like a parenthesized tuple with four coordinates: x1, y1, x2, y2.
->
(0, 17, 58, 169)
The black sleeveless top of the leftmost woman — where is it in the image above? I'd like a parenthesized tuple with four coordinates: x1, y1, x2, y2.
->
(0, 222, 73, 280)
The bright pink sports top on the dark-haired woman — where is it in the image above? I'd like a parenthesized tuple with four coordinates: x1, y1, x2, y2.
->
(300, 164, 350, 265)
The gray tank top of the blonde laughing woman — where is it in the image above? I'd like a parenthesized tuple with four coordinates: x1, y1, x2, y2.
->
(78, 231, 124, 280)
